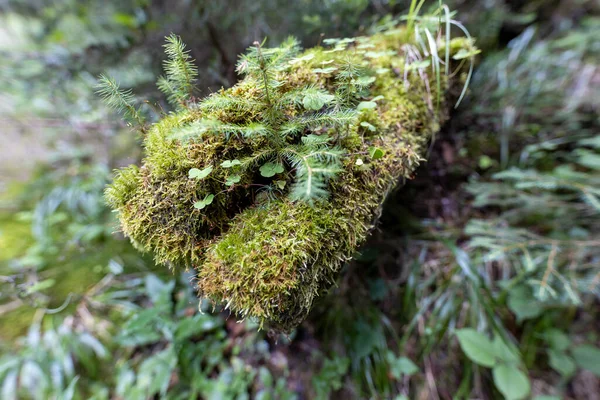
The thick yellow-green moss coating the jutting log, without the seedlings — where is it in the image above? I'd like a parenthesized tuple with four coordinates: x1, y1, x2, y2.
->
(106, 27, 472, 331)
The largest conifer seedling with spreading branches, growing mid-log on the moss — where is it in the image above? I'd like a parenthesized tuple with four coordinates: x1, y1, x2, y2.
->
(175, 39, 358, 206)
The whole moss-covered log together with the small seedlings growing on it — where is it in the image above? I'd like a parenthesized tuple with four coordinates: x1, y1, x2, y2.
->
(106, 7, 473, 331)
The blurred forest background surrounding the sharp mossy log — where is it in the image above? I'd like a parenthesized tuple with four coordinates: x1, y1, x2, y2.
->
(0, 0, 600, 400)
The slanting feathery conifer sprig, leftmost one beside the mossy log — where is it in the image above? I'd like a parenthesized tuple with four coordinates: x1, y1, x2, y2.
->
(96, 74, 146, 132)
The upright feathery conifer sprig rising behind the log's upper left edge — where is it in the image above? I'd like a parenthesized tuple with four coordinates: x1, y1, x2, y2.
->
(157, 34, 198, 107)
